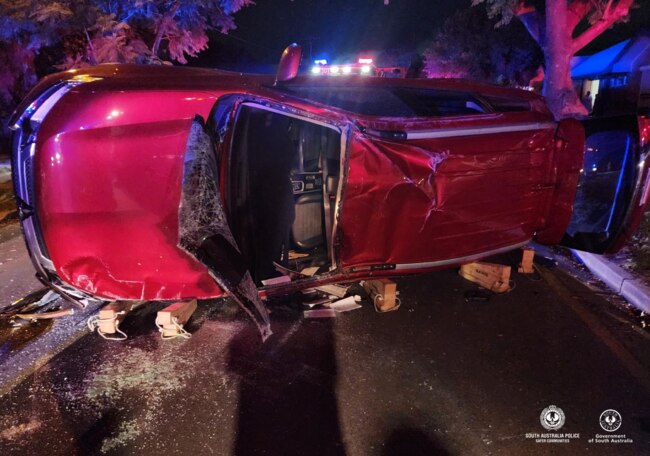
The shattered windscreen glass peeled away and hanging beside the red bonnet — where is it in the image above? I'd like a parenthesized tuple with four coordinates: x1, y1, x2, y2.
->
(178, 117, 272, 340)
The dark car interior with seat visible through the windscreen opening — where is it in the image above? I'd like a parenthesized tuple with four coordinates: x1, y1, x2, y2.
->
(226, 104, 341, 283)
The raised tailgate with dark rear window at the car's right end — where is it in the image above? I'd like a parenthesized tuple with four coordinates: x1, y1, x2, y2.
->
(562, 116, 650, 253)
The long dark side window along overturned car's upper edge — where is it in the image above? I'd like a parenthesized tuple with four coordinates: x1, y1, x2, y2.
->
(284, 86, 491, 117)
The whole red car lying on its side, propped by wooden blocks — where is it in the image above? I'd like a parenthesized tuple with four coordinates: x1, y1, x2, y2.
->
(12, 47, 650, 338)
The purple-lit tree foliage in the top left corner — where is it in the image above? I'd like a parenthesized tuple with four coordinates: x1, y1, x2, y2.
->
(0, 0, 254, 145)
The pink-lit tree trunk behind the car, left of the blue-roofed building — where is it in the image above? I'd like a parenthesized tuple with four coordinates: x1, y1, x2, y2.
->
(543, 0, 587, 120)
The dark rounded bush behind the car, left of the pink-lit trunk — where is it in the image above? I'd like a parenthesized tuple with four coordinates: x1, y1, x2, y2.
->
(425, 8, 542, 85)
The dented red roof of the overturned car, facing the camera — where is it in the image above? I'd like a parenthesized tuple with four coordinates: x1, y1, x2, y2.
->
(339, 124, 555, 269)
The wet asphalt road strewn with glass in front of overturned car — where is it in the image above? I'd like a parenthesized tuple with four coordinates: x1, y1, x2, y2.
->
(0, 221, 650, 456)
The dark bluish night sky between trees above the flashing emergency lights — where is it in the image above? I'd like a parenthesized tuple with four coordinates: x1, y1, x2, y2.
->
(233, 0, 470, 58)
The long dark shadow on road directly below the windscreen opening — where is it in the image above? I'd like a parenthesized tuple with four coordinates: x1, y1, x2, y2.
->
(228, 302, 346, 456)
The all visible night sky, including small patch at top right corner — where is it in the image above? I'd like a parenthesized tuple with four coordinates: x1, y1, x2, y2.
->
(193, 0, 650, 70)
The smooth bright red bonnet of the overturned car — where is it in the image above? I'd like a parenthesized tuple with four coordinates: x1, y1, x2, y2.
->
(35, 86, 221, 300)
